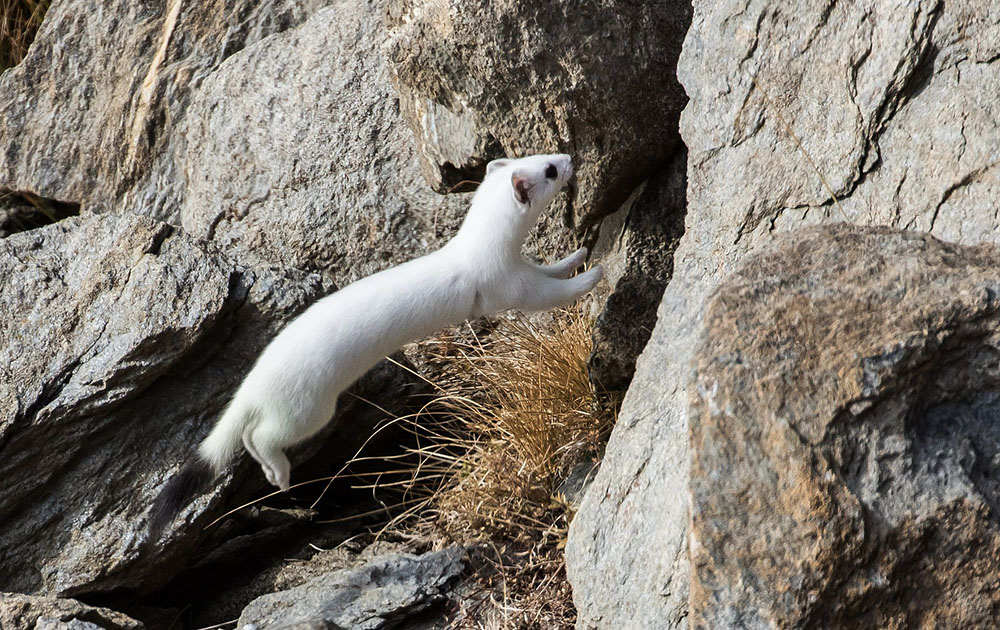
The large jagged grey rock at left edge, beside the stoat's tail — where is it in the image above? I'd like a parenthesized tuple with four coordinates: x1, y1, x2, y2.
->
(0, 215, 250, 593)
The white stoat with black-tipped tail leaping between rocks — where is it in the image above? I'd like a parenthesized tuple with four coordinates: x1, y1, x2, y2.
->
(151, 155, 602, 533)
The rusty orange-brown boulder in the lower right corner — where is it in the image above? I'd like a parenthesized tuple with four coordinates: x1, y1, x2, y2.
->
(690, 226, 1000, 630)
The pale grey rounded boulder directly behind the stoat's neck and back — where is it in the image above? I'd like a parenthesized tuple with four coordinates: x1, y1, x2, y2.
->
(178, 0, 469, 285)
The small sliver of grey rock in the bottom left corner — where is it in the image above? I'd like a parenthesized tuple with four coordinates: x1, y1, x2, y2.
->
(0, 593, 144, 630)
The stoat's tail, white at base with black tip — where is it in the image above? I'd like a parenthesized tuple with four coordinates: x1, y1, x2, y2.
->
(149, 396, 254, 542)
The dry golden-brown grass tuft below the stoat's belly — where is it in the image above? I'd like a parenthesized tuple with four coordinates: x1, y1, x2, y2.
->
(336, 311, 617, 628)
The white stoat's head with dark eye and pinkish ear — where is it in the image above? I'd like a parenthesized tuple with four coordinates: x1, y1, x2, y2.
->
(483, 153, 573, 217)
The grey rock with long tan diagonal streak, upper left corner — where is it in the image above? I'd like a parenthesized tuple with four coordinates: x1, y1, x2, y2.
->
(0, 0, 325, 219)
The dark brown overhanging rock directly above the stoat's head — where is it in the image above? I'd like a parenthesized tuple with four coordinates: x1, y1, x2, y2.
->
(388, 0, 691, 227)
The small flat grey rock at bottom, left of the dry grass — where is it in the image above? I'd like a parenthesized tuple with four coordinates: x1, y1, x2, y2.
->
(238, 547, 465, 630)
